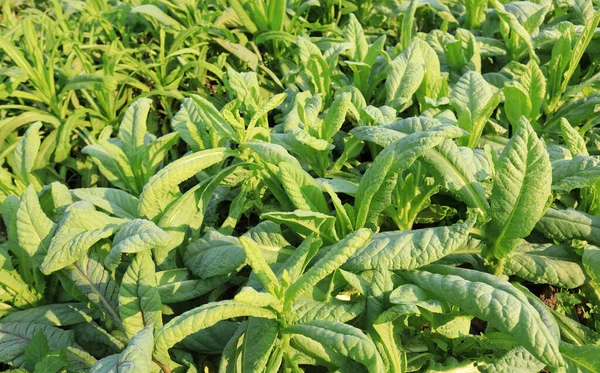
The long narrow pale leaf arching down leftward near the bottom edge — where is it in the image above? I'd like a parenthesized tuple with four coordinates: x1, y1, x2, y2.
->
(154, 300, 275, 361)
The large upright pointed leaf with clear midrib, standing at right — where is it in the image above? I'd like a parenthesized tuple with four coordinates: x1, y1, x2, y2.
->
(486, 118, 552, 259)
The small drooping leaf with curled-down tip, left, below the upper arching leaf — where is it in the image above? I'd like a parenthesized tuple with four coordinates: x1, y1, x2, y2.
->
(104, 219, 169, 271)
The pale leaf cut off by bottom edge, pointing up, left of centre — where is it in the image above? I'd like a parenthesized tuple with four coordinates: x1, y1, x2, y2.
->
(90, 326, 154, 373)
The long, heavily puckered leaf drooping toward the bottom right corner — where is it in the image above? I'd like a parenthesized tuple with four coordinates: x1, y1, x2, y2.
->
(403, 266, 565, 370)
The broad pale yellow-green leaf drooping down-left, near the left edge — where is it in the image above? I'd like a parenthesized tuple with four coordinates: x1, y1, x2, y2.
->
(40, 202, 125, 274)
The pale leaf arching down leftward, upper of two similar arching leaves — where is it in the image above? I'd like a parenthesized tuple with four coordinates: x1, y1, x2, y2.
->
(139, 148, 233, 220)
